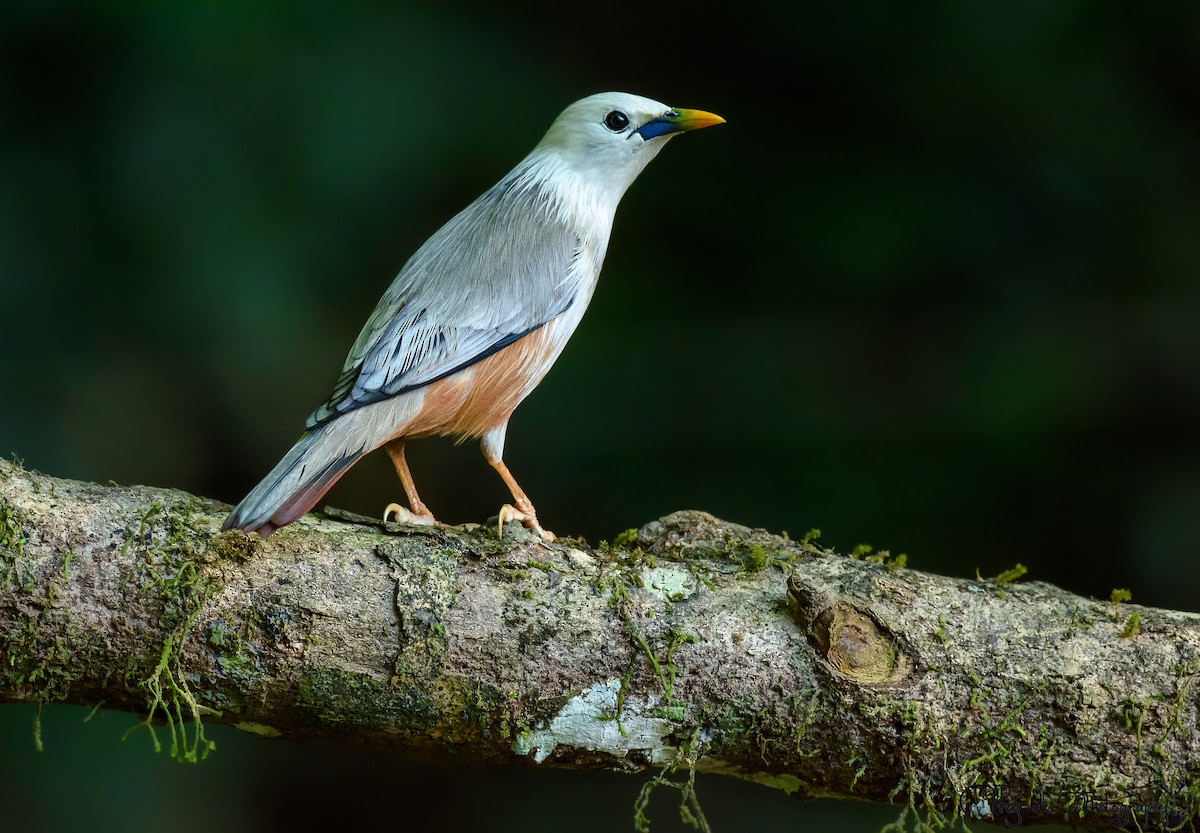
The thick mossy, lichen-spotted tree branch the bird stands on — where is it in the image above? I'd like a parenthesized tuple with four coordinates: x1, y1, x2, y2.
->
(0, 462, 1200, 829)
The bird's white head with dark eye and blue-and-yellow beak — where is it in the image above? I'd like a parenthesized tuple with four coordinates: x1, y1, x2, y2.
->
(530, 92, 725, 198)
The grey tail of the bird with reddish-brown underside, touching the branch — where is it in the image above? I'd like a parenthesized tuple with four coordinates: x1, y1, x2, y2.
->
(221, 419, 371, 538)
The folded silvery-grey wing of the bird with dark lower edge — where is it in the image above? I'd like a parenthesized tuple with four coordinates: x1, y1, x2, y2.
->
(306, 178, 582, 430)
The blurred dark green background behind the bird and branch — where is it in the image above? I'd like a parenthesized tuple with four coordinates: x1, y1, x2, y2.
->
(0, 0, 1200, 831)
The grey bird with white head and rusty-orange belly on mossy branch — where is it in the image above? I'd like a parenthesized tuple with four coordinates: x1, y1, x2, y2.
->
(222, 92, 725, 541)
